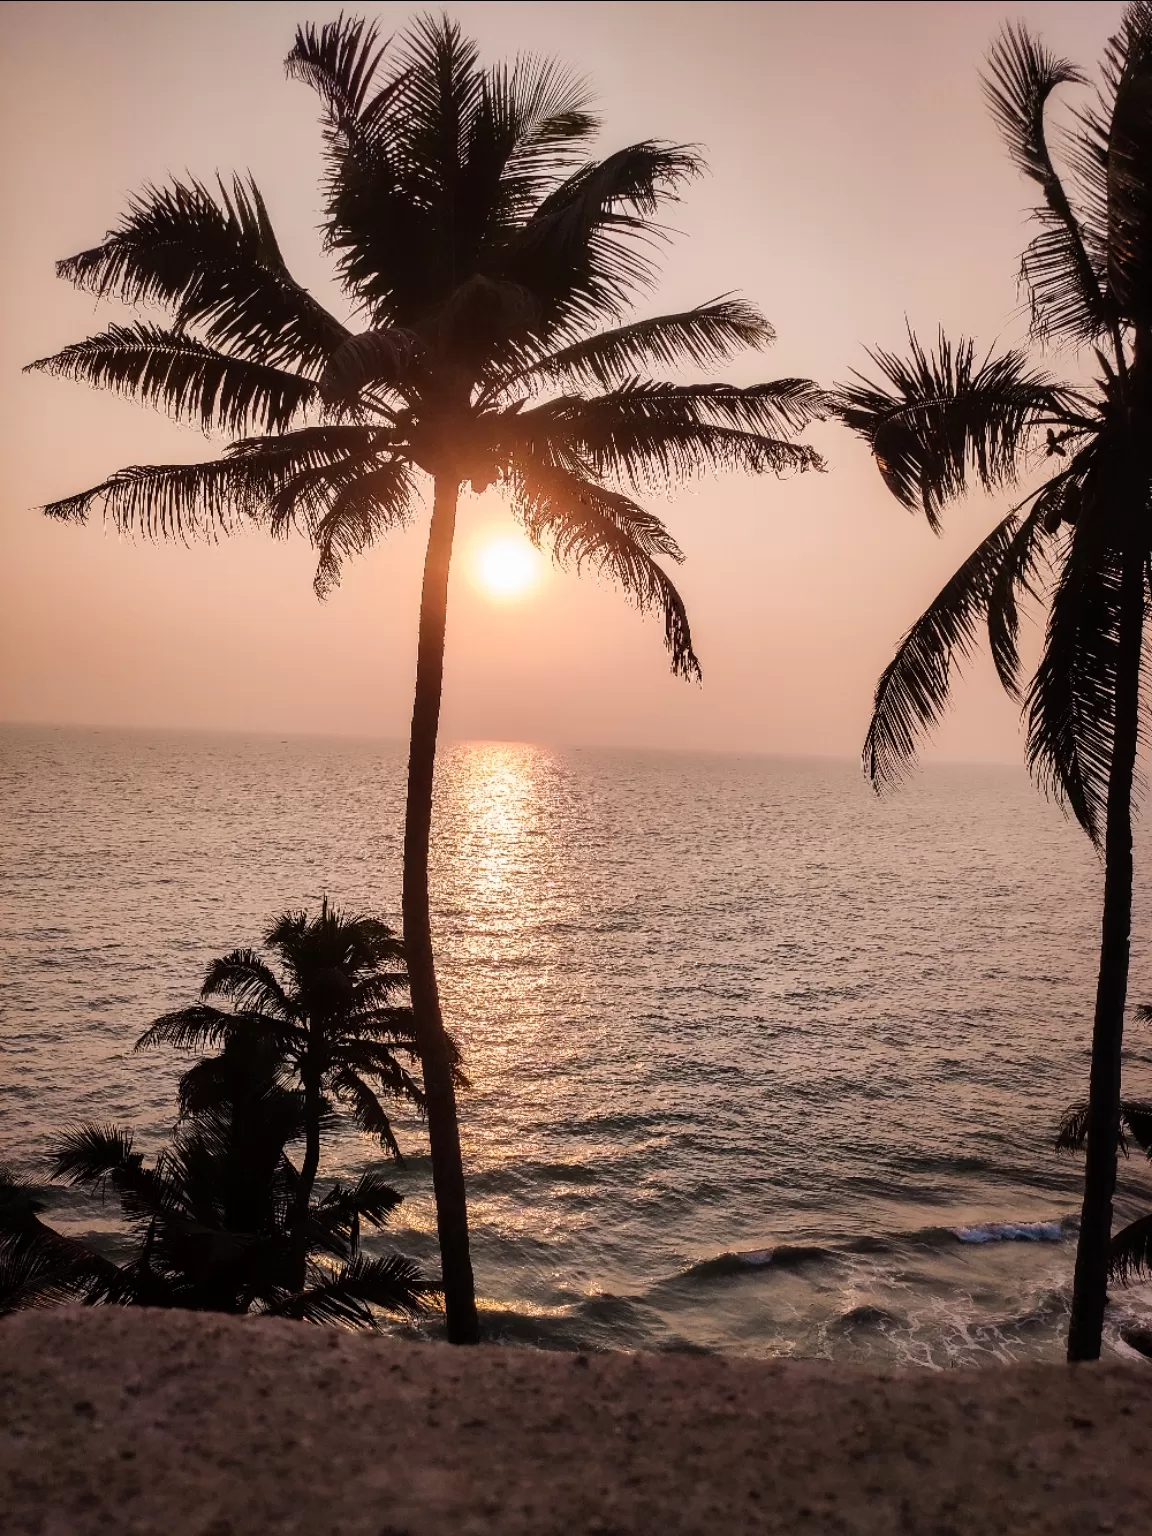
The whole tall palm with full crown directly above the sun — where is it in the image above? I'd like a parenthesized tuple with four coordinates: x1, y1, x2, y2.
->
(24, 18, 822, 1342)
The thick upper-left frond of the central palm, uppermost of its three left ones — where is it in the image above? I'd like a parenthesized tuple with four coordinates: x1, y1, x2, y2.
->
(57, 178, 347, 372)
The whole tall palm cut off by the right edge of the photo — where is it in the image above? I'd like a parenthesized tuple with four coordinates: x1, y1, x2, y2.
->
(839, 3, 1152, 1359)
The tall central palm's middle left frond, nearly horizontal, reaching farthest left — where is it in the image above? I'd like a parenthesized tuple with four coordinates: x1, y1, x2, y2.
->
(25, 321, 316, 433)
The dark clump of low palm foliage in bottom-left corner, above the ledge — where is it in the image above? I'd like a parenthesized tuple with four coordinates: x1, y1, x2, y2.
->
(0, 1034, 433, 1327)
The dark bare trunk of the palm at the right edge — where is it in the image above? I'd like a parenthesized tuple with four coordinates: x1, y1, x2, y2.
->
(1068, 550, 1144, 1361)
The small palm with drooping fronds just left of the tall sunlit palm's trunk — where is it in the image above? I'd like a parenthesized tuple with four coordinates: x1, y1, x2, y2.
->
(137, 897, 424, 1275)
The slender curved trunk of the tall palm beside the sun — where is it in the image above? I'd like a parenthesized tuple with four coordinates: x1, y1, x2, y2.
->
(402, 475, 479, 1344)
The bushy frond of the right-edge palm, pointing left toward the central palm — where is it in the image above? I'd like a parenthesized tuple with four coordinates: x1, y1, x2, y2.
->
(834, 330, 1064, 528)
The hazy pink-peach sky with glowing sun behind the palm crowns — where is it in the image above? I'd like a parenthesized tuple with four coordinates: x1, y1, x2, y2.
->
(0, 3, 1121, 757)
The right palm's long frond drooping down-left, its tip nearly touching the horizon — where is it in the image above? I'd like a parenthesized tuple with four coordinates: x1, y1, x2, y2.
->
(863, 511, 1020, 788)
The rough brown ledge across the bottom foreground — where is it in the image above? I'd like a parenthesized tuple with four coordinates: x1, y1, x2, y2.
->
(0, 1309, 1152, 1536)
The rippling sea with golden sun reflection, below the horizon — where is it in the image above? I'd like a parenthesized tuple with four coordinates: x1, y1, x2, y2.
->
(0, 728, 1152, 1369)
